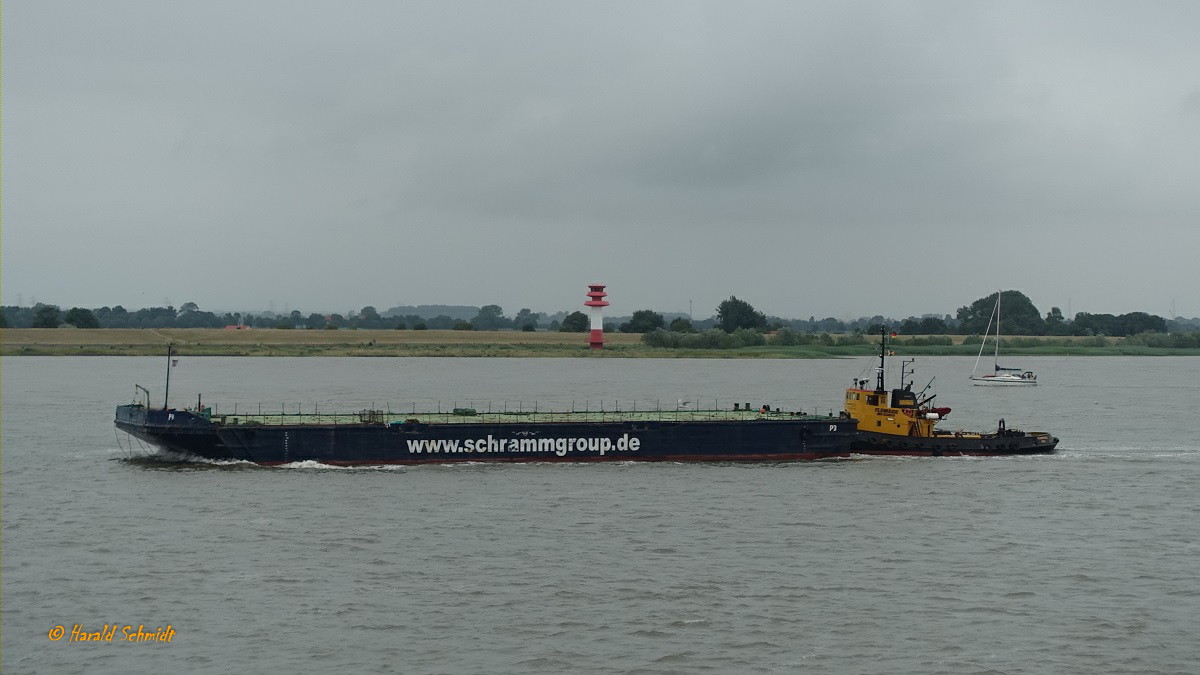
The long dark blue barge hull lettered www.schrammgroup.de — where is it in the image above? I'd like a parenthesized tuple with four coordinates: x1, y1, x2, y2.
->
(115, 405, 857, 466)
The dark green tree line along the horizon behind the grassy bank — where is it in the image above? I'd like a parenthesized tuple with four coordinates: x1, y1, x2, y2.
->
(0, 291, 1200, 341)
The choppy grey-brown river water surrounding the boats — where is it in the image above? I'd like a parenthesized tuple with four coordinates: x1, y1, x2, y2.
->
(2, 357, 1200, 674)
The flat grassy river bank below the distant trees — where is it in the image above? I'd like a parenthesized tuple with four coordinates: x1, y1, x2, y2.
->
(0, 328, 1200, 359)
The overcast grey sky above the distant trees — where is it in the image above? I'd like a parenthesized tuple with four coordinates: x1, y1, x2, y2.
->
(0, 0, 1200, 318)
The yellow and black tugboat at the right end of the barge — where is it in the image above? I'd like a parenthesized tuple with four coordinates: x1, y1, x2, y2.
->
(841, 331, 1058, 456)
